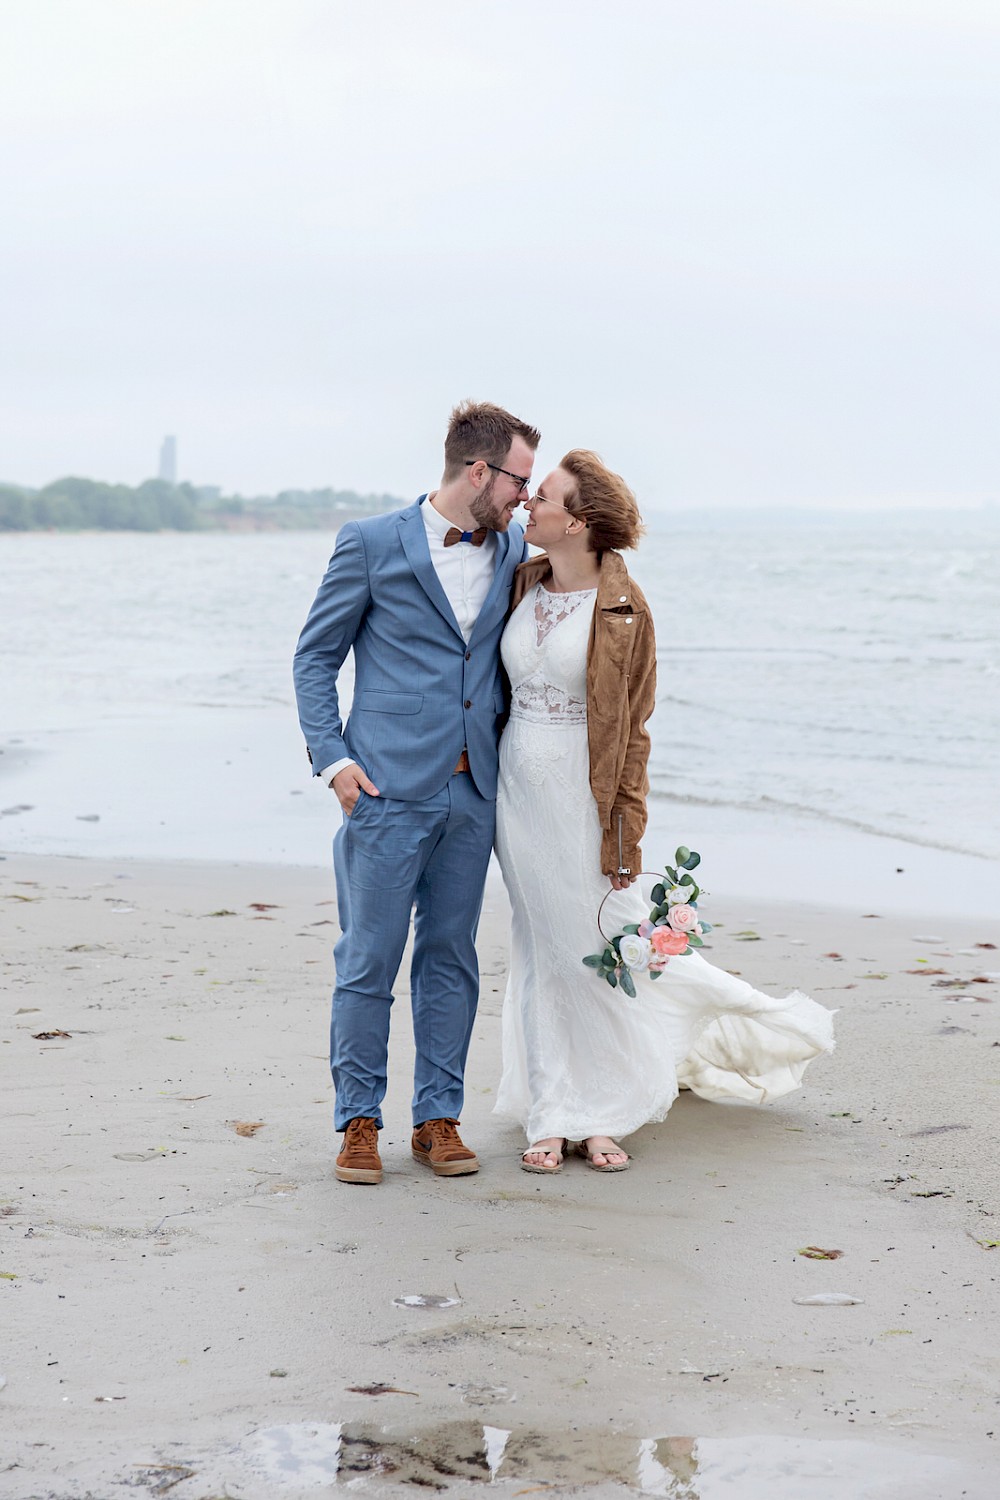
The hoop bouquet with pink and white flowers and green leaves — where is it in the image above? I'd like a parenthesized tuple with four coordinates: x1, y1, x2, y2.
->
(583, 845, 712, 999)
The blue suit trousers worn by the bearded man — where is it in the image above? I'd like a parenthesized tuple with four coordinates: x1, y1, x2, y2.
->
(330, 774, 496, 1131)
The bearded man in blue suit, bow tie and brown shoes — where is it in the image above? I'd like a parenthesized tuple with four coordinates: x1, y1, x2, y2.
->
(295, 402, 540, 1182)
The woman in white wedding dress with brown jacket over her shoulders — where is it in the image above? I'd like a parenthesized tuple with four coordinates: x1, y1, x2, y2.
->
(496, 449, 834, 1173)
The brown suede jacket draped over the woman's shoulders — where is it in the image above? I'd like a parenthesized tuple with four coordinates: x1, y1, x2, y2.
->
(510, 552, 657, 875)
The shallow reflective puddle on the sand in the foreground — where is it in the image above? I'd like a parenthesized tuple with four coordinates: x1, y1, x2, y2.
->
(241, 1422, 985, 1500)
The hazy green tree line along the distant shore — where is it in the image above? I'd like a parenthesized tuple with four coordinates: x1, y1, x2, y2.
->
(0, 477, 403, 531)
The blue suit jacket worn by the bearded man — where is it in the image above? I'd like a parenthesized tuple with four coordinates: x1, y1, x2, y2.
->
(294, 495, 526, 801)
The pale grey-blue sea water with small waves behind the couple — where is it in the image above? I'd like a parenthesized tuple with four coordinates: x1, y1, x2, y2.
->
(0, 510, 1000, 915)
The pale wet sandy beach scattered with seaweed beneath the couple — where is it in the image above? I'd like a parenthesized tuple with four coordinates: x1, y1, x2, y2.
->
(0, 857, 1000, 1500)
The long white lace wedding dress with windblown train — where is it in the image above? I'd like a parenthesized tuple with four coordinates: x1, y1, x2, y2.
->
(496, 584, 834, 1142)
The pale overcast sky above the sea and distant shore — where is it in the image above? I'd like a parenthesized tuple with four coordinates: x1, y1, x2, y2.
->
(0, 0, 1000, 509)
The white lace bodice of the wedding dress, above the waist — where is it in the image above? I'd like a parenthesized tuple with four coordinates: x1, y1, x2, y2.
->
(501, 584, 597, 726)
